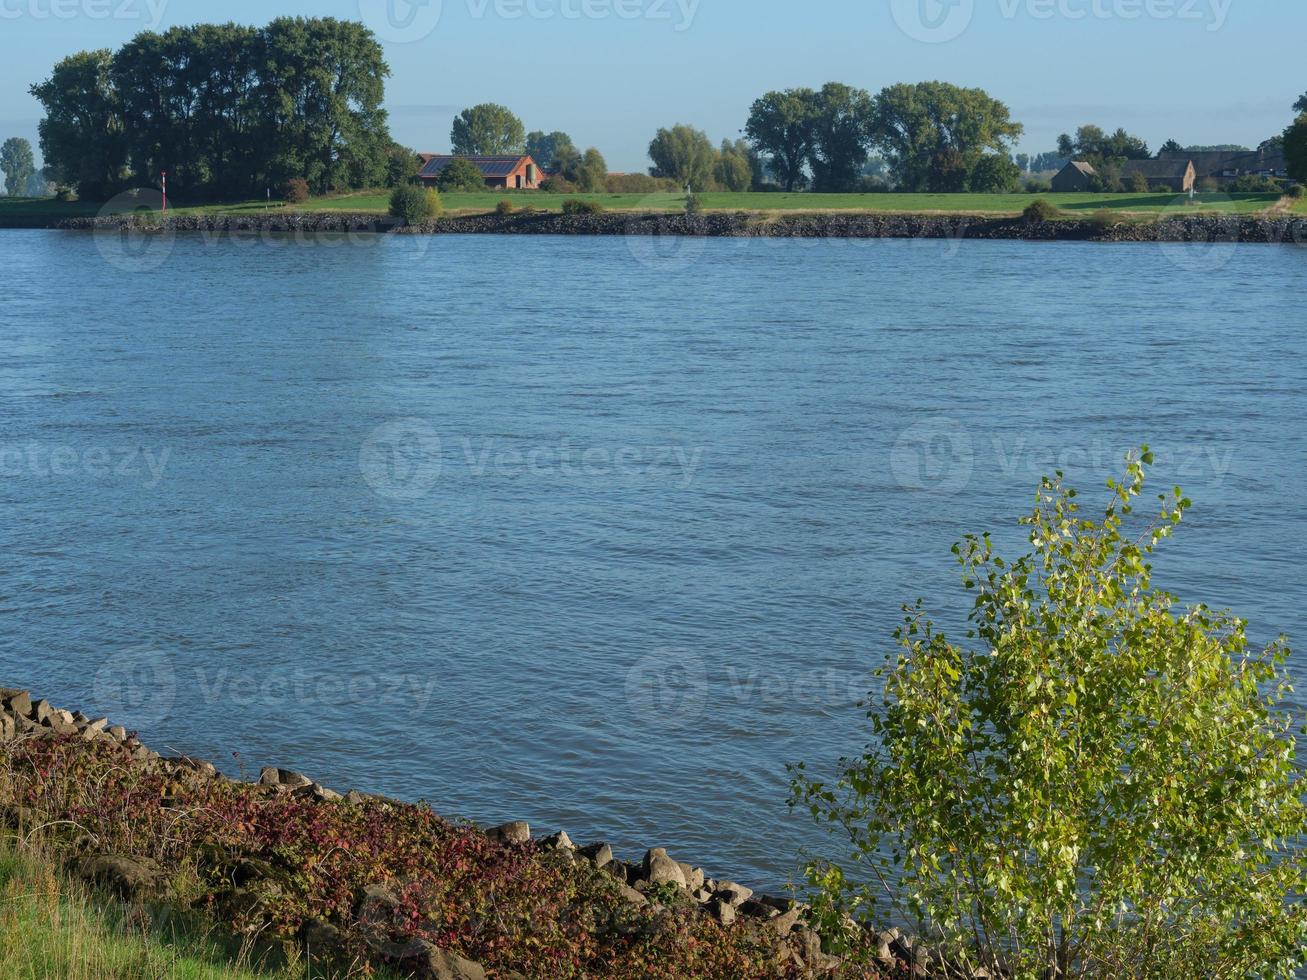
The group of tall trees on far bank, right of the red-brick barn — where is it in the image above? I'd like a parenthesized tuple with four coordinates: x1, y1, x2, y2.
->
(745, 82, 1023, 192)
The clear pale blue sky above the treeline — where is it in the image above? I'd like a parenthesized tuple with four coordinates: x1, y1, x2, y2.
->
(0, 0, 1307, 171)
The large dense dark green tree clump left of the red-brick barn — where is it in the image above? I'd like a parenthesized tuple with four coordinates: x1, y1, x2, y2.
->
(31, 17, 394, 199)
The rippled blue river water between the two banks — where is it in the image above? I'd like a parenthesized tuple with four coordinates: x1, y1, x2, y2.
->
(0, 231, 1307, 886)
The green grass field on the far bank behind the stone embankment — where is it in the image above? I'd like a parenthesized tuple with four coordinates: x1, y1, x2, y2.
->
(0, 191, 1307, 222)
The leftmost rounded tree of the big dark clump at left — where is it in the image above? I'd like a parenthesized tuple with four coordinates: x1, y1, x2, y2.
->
(30, 50, 127, 200)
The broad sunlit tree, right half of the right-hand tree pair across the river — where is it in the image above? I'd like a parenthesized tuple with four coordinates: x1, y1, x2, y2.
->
(870, 81, 1025, 191)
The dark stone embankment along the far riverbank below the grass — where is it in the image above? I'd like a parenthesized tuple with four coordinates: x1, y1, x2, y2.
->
(10, 210, 1307, 244)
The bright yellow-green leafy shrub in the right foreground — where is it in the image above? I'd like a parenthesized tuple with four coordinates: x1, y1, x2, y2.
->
(793, 449, 1307, 980)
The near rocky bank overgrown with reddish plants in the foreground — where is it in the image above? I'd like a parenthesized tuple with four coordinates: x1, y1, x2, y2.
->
(0, 689, 961, 980)
